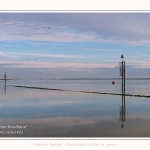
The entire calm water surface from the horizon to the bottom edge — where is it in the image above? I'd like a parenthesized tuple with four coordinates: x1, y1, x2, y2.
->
(0, 80, 150, 137)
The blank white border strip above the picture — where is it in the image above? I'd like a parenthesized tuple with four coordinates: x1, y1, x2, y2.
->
(0, 0, 150, 11)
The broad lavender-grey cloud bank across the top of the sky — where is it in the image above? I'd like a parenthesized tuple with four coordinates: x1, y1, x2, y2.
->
(0, 13, 150, 45)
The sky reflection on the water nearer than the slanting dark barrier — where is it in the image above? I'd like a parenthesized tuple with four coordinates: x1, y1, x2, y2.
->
(0, 81, 150, 137)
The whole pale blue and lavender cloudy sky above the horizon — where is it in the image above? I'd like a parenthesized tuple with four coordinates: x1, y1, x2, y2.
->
(0, 12, 150, 79)
